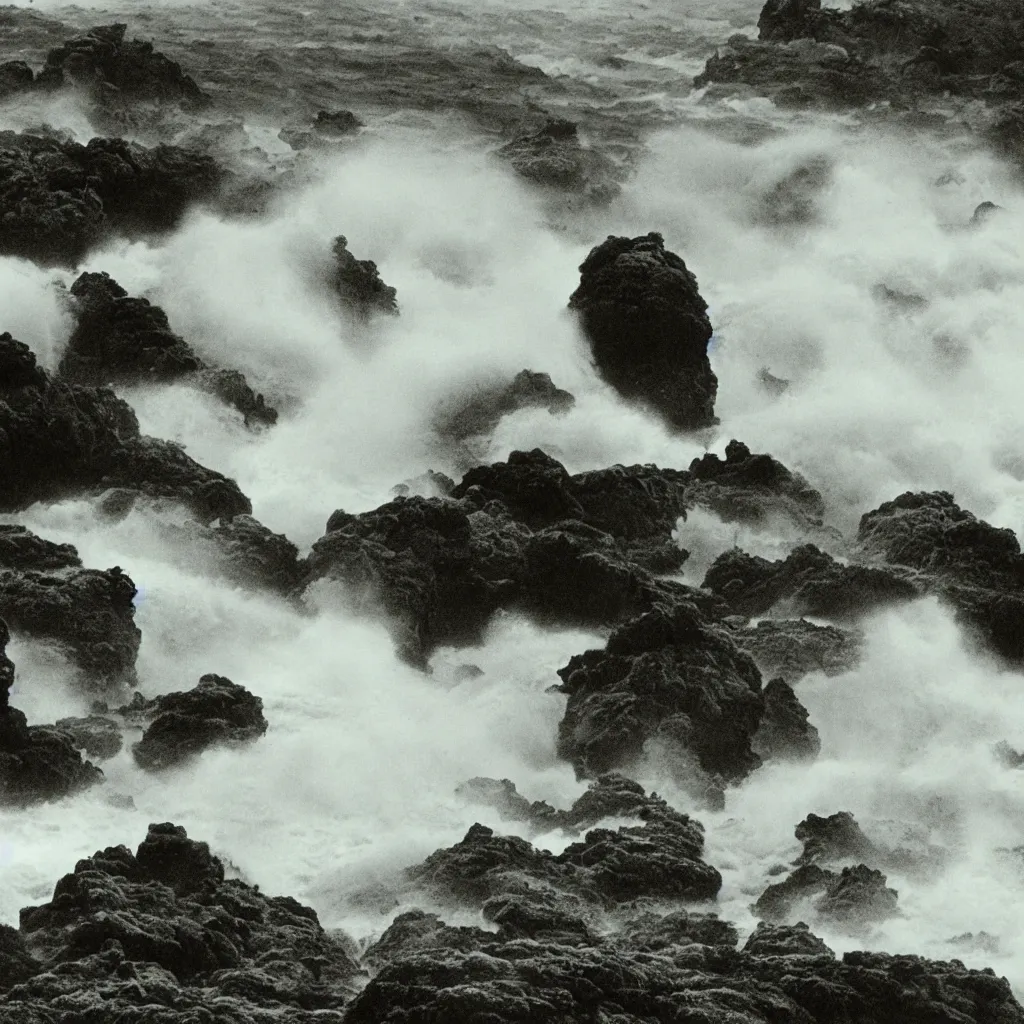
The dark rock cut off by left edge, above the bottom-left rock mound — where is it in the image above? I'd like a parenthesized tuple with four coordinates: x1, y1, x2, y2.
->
(0, 618, 103, 802)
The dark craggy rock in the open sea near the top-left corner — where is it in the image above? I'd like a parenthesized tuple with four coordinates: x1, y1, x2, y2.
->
(39, 25, 210, 111)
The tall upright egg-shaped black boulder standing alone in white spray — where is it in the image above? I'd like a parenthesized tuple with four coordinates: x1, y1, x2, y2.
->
(569, 231, 718, 430)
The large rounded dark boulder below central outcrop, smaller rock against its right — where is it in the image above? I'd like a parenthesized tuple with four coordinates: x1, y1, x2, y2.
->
(558, 603, 765, 788)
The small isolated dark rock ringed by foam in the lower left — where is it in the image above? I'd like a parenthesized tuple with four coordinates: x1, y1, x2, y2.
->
(120, 675, 267, 771)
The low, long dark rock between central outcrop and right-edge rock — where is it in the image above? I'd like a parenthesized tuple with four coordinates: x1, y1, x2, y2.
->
(702, 544, 922, 621)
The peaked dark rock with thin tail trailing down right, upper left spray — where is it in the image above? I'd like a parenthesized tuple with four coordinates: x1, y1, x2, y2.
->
(57, 273, 278, 426)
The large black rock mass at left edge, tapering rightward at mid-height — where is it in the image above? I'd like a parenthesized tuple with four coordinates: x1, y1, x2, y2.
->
(0, 334, 252, 522)
